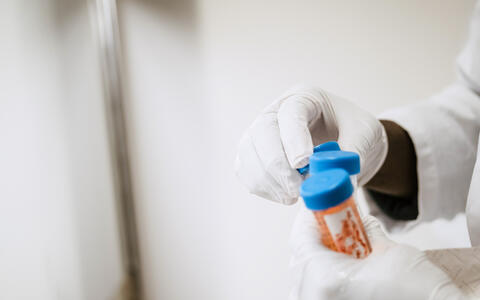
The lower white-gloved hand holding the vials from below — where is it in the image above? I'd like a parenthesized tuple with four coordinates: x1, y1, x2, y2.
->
(290, 207, 466, 300)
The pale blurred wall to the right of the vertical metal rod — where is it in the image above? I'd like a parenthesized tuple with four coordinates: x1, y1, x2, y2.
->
(121, 0, 473, 300)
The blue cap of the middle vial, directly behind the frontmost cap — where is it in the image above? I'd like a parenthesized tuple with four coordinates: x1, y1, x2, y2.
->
(309, 151, 360, 175)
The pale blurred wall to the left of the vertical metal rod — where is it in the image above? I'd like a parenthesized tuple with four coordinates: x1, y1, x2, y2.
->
(0, 0, 123, 300)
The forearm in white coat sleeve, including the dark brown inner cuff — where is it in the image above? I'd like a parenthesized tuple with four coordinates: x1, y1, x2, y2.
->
(366, 83, 480, 221)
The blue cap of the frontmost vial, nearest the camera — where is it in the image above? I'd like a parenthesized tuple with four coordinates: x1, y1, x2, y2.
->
(300, 169, 353, 210)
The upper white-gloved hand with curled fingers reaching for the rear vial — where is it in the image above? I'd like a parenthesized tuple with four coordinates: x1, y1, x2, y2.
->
(235, 86, 387, 204)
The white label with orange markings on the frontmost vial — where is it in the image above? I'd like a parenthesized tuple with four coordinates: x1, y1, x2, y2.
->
(324, 206, 370, 258)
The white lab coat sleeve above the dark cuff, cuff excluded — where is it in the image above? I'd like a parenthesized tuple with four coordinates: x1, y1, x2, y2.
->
(380, 83, 480, 223)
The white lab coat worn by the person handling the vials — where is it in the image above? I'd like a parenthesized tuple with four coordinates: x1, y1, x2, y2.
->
(369, 2, 480, 246)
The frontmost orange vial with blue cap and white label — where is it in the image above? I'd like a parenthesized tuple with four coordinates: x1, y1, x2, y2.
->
(300, 169, 372, 258)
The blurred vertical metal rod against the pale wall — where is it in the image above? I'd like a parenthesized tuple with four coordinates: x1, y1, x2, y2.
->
(90, 0, 142, 300)
